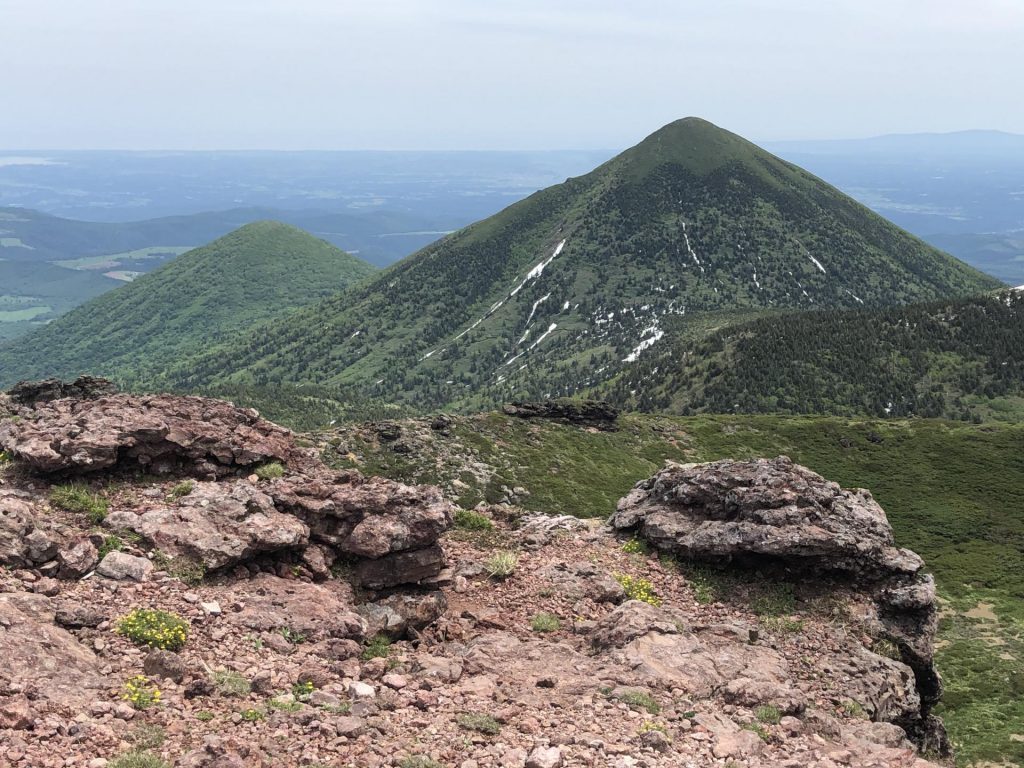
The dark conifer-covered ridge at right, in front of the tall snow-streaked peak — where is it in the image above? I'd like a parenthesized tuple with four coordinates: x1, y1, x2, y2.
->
(600, 291, 1024, 422)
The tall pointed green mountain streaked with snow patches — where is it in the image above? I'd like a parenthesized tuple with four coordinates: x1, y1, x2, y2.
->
(164, 118, 998, 408)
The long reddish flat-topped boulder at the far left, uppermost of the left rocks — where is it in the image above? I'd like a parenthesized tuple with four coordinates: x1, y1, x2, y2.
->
(0, 394, 303, 476)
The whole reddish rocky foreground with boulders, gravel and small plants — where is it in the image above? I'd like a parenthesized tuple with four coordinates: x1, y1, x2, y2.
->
(0, 387, 944, 768)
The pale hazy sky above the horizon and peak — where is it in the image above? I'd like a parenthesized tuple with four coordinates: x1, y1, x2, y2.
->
(0, 0, 1024, 150)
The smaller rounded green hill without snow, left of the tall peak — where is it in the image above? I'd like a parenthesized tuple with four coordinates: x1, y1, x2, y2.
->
(0, 221, 376, 385)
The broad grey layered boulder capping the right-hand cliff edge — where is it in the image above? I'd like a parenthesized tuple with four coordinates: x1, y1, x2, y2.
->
(611, 456, 924, 581)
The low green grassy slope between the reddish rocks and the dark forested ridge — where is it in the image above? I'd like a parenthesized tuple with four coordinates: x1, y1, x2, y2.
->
(327, 414, 1024, 765)
